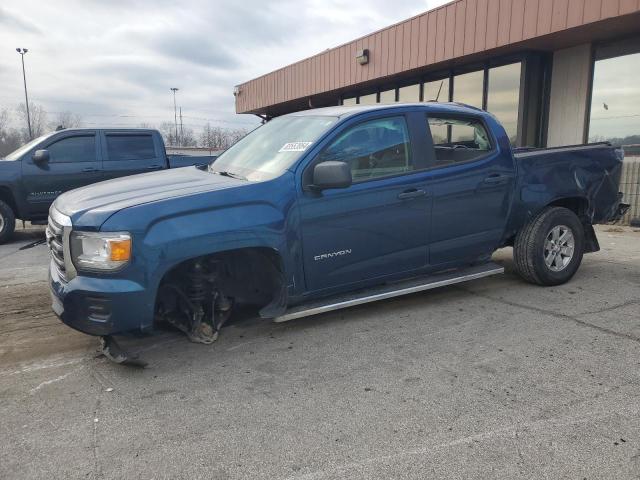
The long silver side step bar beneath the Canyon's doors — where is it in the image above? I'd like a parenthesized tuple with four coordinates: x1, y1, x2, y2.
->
(273, 262, 504, 323)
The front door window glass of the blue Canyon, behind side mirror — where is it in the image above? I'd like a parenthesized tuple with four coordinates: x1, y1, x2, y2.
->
(319, 116, 414, 182)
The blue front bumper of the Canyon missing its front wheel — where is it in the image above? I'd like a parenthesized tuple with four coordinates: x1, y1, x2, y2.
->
(49, 264, 155, 335)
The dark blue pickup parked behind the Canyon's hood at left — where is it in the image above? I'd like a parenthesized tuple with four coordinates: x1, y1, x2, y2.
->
(0, 129, 206, 244)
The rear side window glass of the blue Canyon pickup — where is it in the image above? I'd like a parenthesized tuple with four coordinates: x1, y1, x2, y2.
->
(427, 114, 494, 167)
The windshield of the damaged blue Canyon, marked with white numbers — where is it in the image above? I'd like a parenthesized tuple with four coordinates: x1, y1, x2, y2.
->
(209, 116, 338, 181)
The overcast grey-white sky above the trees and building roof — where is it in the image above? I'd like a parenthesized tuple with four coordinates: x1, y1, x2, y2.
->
(0, 0, 447, 135)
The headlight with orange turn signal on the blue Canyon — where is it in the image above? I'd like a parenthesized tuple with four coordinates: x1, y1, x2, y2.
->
(70, 232, 131, 271)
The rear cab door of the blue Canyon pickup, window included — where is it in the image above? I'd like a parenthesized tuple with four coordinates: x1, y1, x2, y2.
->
(426, 113, 514, 266)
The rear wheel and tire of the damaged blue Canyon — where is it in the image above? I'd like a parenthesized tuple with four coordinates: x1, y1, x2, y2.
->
(513, 207, 585, 286)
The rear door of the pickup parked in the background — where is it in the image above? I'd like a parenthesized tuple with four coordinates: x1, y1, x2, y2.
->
(102, 130, 166, 179)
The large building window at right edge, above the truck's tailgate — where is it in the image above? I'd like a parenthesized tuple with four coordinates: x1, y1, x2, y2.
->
(589, 53, 640, 146)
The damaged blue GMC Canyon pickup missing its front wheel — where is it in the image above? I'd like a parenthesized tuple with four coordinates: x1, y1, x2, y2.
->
(47, 103, 626, 360)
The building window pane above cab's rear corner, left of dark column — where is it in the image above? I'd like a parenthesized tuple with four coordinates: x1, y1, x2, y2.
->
(487, 62, 522, 144)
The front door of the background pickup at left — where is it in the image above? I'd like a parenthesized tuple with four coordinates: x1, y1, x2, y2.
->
(22, 130, 103, 217)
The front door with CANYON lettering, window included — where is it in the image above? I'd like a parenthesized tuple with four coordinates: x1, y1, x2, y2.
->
(299, 115, 430, 291)
